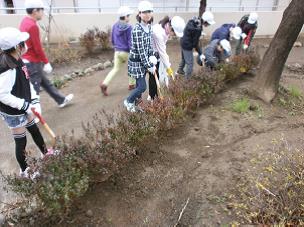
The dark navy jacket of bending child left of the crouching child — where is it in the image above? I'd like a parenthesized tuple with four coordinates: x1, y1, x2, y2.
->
(181, 17, 203, 54)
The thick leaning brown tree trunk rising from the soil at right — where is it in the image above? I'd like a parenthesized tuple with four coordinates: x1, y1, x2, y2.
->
(253, 0, 304, 103)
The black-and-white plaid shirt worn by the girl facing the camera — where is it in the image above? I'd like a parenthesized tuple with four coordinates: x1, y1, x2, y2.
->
(128, 23, 153, 78)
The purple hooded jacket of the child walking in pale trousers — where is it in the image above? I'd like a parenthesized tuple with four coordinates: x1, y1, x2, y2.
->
(112, 21, 132, 52)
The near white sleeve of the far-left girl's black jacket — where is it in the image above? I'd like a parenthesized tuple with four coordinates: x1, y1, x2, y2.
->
(0, 69, 25, 110)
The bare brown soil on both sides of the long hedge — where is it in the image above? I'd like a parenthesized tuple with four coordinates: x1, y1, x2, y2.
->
(0, 39, 304, 226)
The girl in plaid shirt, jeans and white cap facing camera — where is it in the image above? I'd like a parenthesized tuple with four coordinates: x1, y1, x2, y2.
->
(124, 1, 157, 112)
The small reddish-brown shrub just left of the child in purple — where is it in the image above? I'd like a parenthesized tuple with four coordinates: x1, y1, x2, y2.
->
(79, 27, 111, 54)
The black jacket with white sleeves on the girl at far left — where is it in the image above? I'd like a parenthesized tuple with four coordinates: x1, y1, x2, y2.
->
(0, 54, 38, 115)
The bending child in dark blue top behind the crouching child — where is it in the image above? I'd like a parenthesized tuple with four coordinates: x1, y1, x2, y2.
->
(211, 23, 242, 41)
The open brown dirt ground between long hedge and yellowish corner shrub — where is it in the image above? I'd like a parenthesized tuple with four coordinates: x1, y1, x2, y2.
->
(61, 71, 304, 226)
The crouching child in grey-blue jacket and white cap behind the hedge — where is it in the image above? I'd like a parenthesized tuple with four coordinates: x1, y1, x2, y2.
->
(204, 39, 231, 69)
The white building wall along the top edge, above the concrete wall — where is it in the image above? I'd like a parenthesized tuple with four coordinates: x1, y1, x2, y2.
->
(0, 0, 290, 14)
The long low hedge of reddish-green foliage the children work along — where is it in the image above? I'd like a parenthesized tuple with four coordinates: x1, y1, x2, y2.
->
(1, 52, 260, 225)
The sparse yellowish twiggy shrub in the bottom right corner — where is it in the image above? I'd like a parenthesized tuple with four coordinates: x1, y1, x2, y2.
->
(229, 139, 304, 226)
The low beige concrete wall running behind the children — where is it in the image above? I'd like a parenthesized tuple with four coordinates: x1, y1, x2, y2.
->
(0, 11, 302, 41)
